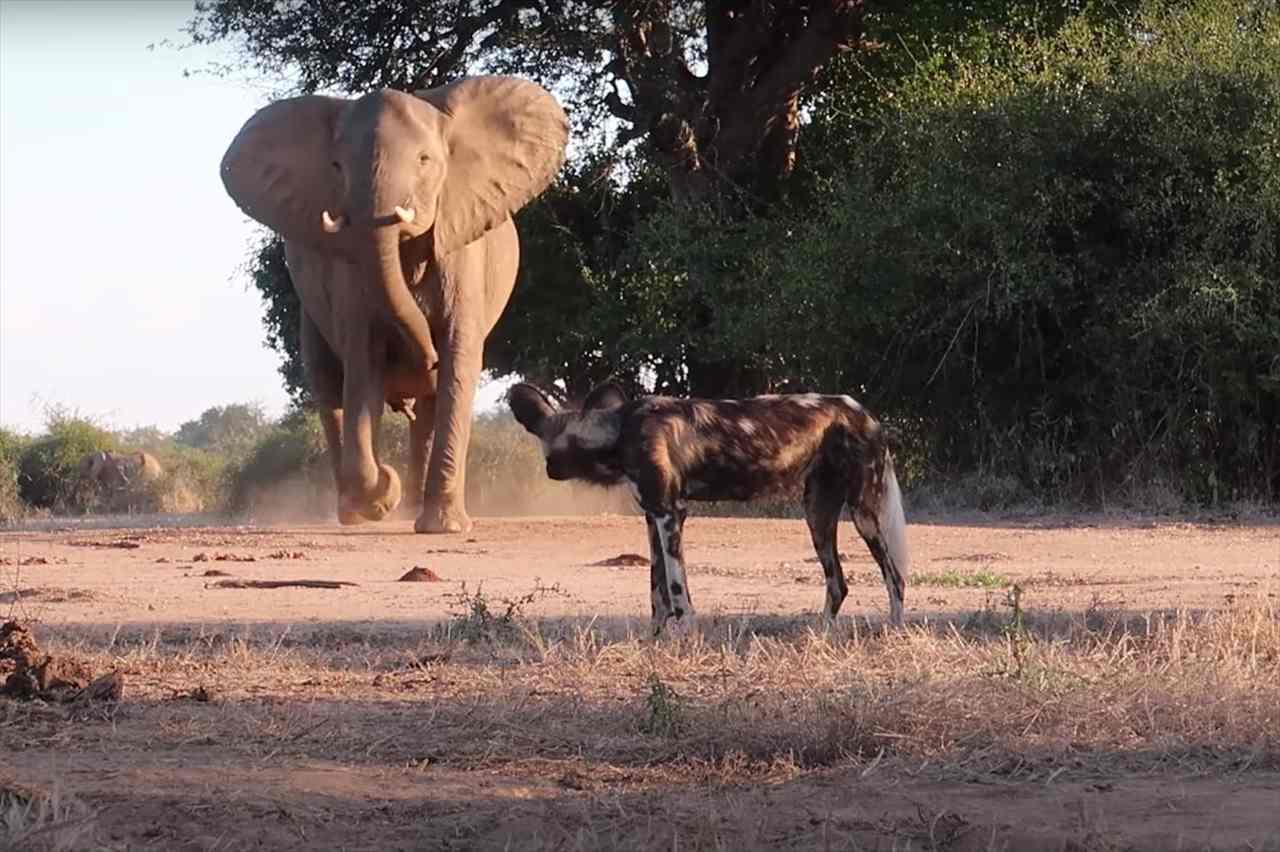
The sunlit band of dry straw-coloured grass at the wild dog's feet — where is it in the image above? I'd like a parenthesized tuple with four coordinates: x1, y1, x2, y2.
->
(22, 595, 1280, 783)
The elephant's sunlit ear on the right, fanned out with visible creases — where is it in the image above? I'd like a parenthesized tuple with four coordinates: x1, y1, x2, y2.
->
(415, 75, 568, 256)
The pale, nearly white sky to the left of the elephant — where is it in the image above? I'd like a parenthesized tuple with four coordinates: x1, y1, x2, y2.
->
(0, 0, 514, 432)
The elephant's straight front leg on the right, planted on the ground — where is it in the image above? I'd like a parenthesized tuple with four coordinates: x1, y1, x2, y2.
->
(413, 323, 484, 532)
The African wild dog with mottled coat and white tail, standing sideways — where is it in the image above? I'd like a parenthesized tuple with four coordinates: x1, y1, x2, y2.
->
(508, 384, 908, 633)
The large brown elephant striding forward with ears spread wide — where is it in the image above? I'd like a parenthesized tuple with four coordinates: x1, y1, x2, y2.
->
(220, 75, 568, 533)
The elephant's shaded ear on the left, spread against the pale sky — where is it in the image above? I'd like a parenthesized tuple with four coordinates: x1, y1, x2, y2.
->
(221, 95, 348, 246)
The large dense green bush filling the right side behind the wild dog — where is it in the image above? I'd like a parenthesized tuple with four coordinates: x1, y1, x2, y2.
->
(632, 0, 1280, 505)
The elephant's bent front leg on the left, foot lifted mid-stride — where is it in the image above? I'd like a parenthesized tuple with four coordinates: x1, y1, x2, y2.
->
(338, 327, 401, 523)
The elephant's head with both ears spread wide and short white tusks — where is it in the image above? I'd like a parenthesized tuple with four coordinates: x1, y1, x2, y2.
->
(221, 77, 568, 258)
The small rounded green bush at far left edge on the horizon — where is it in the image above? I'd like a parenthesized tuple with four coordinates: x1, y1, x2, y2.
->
(18, 408, 115, 510)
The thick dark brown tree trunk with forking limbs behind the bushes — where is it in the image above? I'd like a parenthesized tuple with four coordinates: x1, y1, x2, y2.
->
(609, 0, 863, 397)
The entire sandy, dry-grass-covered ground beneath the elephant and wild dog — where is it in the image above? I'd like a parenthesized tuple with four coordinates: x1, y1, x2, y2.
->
(0, 506, 1280, 851)
